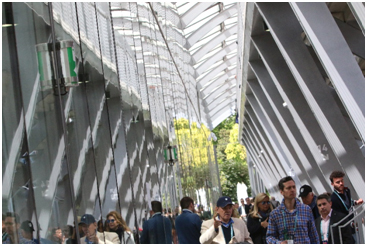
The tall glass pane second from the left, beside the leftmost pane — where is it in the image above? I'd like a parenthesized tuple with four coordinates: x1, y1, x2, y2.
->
(7, 3, 74, 243)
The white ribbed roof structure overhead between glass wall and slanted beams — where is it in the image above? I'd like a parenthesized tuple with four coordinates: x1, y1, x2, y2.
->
(112, 2, 244, 129)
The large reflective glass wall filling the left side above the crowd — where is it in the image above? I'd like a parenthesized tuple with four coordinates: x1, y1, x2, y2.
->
(2, 2, 221, 243)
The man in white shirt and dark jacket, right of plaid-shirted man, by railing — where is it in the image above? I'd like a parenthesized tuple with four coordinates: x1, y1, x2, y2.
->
(315, 194, 354, 244)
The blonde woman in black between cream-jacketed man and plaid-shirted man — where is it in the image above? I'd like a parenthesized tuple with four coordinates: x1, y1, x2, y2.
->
(247, 193, 273, 244)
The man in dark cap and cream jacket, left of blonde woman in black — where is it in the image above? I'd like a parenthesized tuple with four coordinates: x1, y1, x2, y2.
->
(200, 196, 252, 244)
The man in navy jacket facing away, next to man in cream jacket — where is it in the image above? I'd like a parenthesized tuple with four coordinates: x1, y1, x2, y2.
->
(175, 197, 202, 244)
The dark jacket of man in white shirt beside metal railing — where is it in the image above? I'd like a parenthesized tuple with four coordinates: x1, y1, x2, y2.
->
(315, 209, 354, 244)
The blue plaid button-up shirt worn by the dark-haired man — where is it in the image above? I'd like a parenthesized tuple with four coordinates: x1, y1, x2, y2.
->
(266, 199, 320, 244)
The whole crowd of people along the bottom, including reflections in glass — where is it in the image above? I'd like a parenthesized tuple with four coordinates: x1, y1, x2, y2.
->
(2, 171, 363, 244)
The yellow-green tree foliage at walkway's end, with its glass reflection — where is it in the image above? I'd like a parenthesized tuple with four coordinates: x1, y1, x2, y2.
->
(174, 116, 250, 202)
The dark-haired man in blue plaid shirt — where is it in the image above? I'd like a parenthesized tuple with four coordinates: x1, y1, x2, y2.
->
(266, 176, 319, 244)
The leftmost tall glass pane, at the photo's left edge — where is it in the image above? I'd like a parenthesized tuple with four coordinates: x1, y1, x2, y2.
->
(2, 3, 39, 243)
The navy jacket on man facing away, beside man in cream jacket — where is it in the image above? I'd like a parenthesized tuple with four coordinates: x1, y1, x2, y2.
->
(175, 210, 202, 244)
